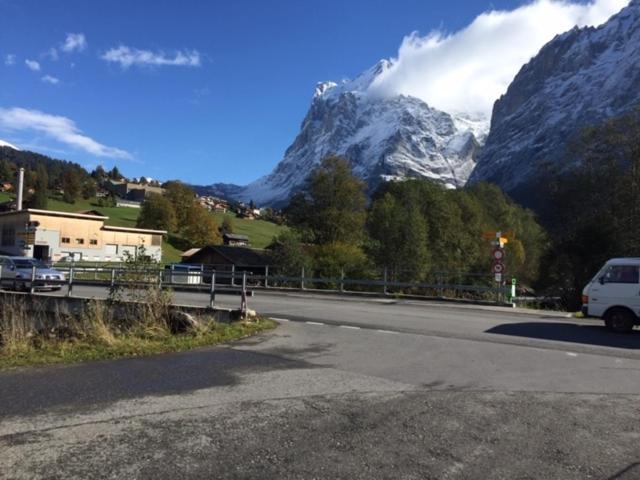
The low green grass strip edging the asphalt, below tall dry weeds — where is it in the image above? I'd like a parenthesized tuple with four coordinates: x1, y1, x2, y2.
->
(0, 319, 276, 369)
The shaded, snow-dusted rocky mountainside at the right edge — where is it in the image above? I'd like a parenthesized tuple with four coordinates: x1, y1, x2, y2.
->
(470, 0, 640, 199)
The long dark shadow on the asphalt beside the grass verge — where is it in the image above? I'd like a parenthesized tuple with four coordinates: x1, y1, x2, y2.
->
(0, 347, 315, 419)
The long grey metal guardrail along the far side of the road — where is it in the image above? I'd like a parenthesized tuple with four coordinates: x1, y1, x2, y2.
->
(0, 264, 512, 311)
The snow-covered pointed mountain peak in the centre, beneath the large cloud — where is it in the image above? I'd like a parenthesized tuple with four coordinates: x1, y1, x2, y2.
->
(218, 60, 488, 205)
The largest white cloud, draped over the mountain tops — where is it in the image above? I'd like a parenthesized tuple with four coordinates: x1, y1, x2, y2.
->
(371, 0, 629, 115)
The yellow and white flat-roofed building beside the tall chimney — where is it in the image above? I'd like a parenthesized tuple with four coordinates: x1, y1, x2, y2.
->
(0, 209, 167, 262)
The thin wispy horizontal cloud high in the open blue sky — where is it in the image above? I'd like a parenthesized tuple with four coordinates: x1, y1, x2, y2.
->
(100, 45, 200, 68)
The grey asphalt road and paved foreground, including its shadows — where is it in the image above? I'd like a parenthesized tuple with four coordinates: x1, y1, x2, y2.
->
(0, 292, 640, 479)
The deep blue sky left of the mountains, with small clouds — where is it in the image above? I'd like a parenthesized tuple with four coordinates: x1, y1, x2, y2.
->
(0, 0, 621, 184)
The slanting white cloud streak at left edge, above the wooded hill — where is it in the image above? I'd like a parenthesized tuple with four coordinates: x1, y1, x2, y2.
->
(0, 108, 132, 159)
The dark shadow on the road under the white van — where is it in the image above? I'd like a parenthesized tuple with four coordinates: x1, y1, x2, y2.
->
(486, 322, 640, 350)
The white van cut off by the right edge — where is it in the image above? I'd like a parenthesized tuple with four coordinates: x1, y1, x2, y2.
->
(582, 258, 640, 333)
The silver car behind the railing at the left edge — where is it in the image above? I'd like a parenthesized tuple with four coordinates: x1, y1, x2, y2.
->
(0, 256, 65, 290)
